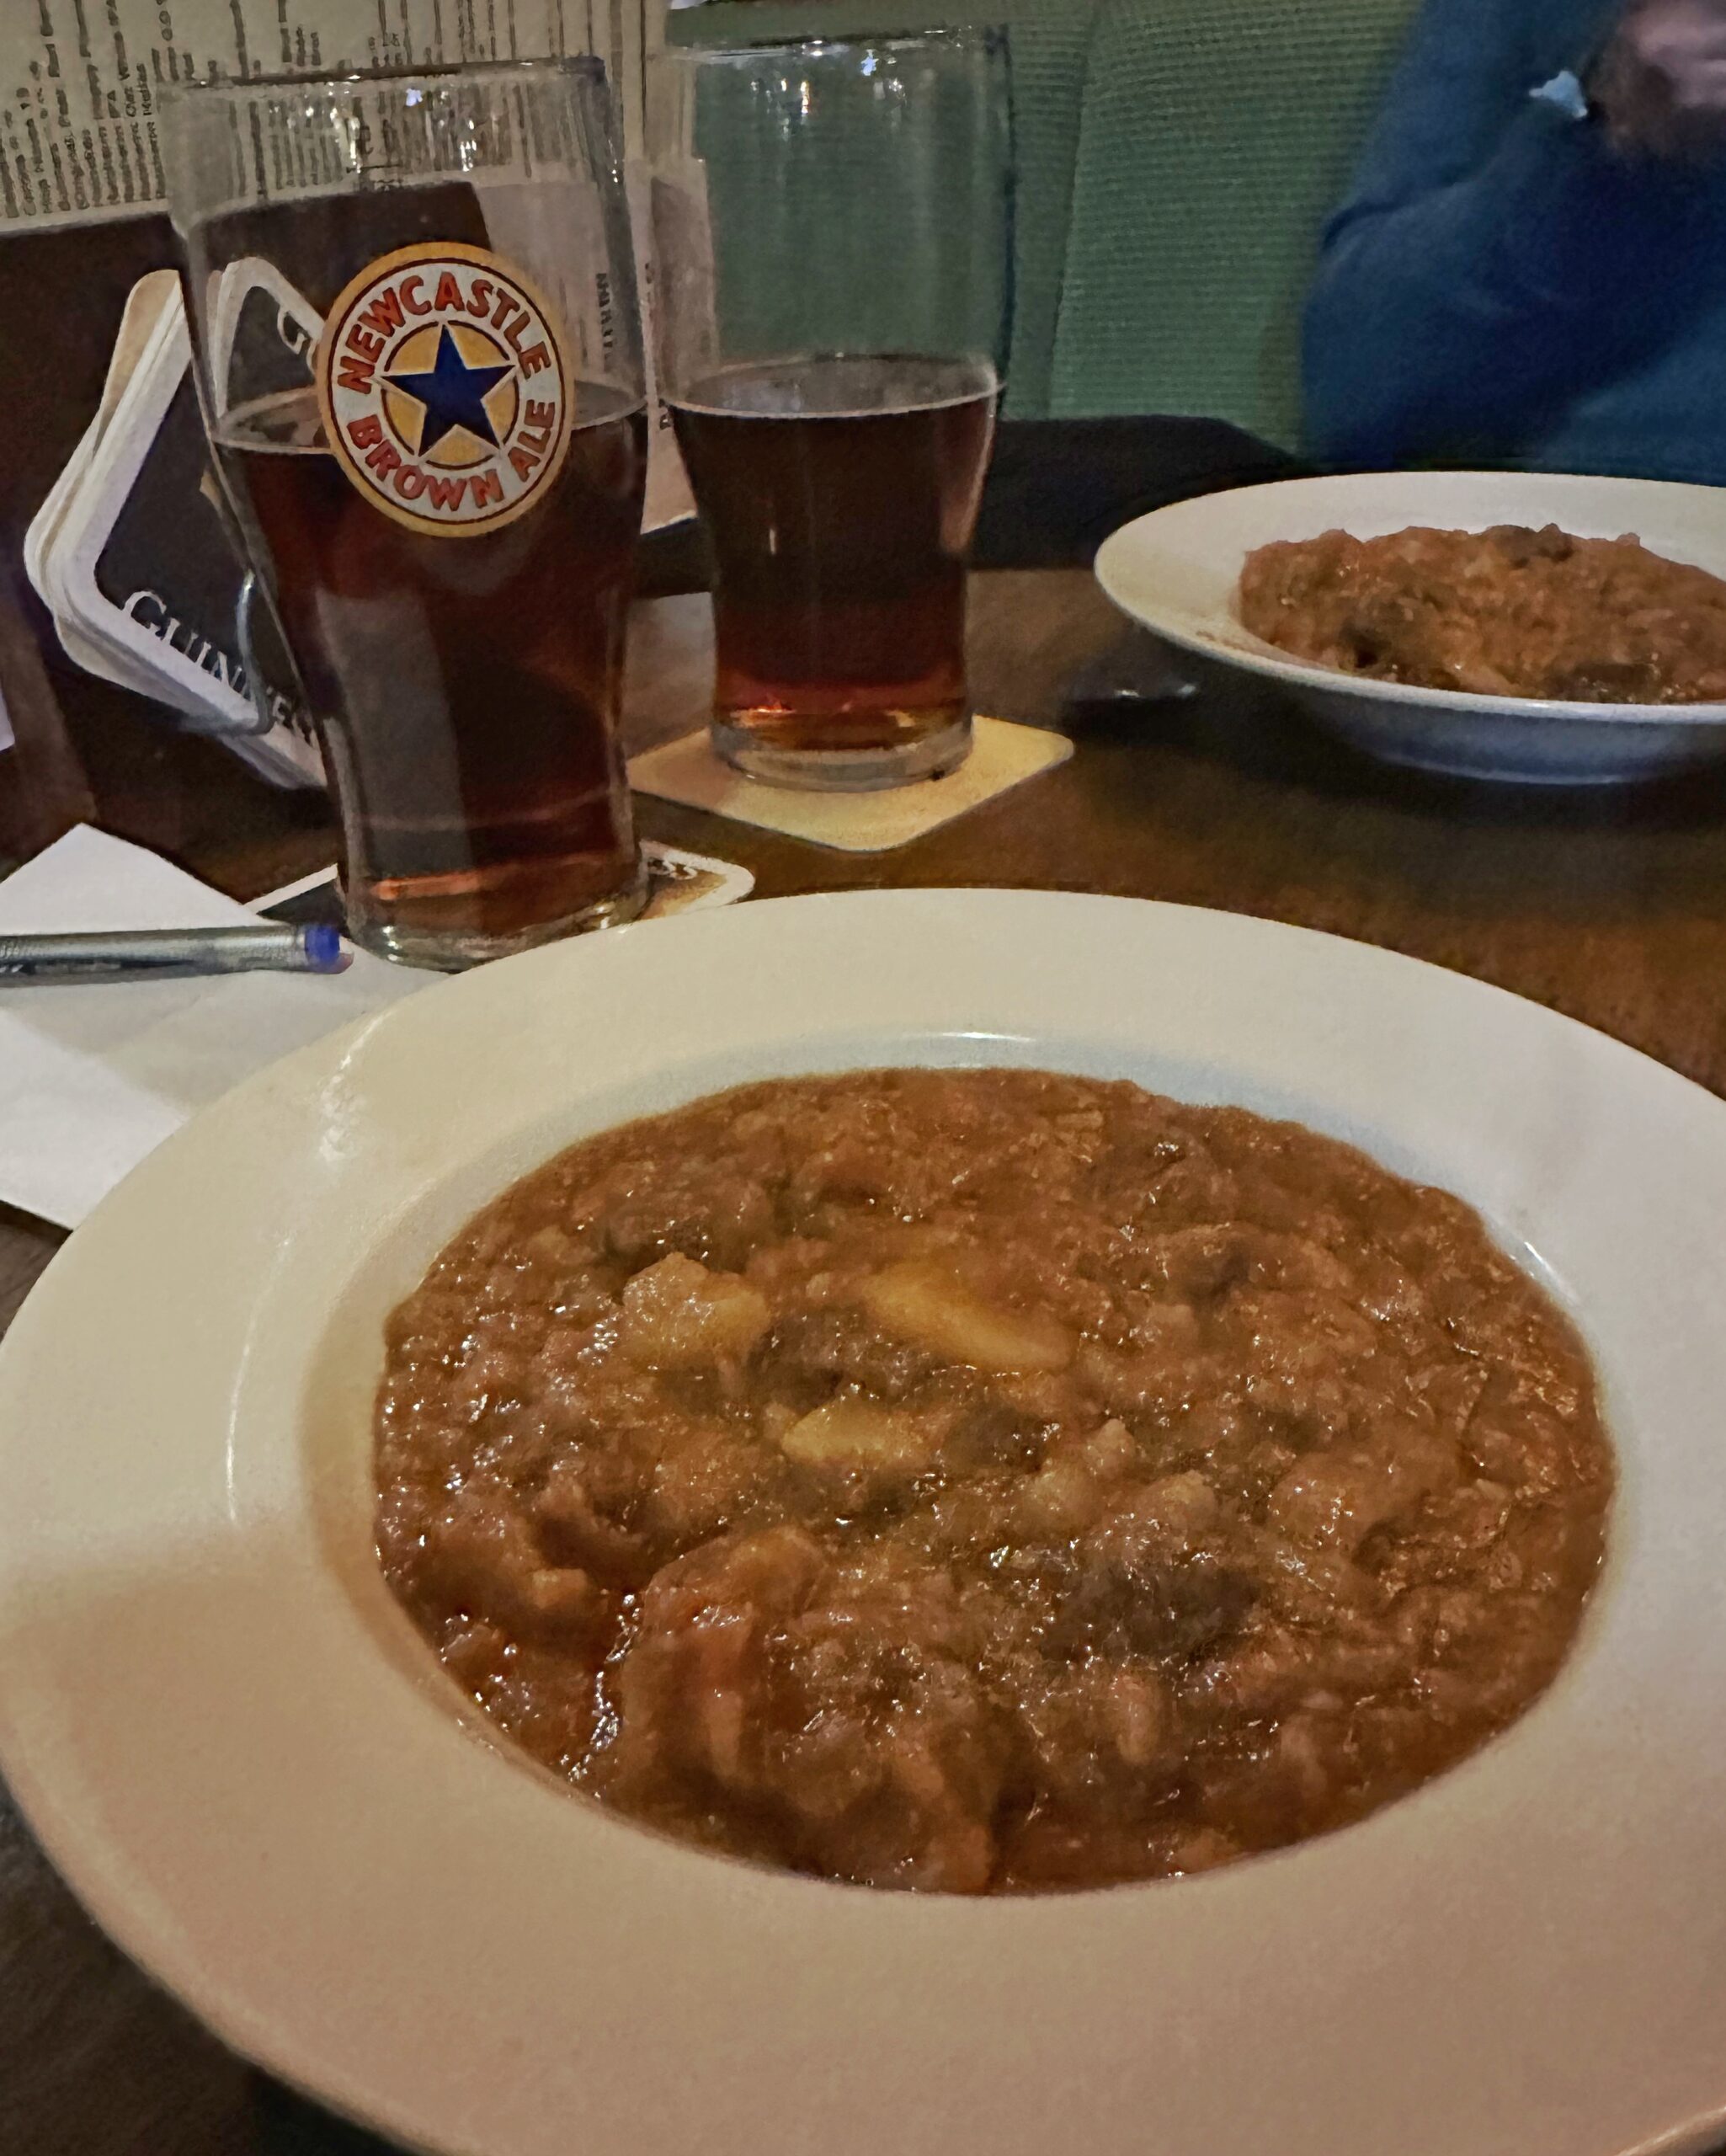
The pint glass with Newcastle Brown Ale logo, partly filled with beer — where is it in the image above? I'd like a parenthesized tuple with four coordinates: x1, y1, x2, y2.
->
(164, 61, 647, 968)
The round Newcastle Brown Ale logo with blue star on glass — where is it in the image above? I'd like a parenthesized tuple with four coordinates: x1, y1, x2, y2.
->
(317, 239, 571, 539)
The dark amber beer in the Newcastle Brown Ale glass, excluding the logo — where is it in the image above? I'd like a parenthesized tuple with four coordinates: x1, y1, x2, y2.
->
(216, 390, 647, 958)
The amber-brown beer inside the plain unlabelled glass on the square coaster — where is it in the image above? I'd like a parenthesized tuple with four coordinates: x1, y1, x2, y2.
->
(673, 355, 995, 785)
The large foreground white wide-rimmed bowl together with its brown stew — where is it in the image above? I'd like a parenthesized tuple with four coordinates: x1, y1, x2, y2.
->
(0, 890, 1726, 2156)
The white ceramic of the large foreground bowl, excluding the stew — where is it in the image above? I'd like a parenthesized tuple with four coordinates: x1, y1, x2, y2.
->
(0, 890, 1726, 2156)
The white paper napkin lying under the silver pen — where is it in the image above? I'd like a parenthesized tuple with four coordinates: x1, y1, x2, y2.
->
(0, 824, 429, 1227)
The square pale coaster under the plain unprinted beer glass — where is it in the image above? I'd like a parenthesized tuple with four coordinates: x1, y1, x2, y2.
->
(629, 718, 1073, 854)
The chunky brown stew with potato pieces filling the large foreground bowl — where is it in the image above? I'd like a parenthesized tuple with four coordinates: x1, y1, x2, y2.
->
(377, 1070, 1611, 1893)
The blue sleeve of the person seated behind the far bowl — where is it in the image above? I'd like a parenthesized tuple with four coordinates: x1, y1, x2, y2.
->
(1306, 0, 1707, 468)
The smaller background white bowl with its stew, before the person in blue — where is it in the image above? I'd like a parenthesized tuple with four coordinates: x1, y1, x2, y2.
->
(1097, 472, 1726, 785)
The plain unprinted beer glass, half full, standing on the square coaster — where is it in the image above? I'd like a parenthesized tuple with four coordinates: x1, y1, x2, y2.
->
(651, 30, 1013, 792)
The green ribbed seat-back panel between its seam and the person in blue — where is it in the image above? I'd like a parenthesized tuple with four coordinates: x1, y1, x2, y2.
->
(1049, 0, 1413, 446)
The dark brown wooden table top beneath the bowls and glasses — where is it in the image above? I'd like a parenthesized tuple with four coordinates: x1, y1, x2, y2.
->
(0, 429, 1726, 2156)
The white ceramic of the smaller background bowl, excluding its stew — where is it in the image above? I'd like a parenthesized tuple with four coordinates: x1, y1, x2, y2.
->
(1097, 472, 1726, 785)
